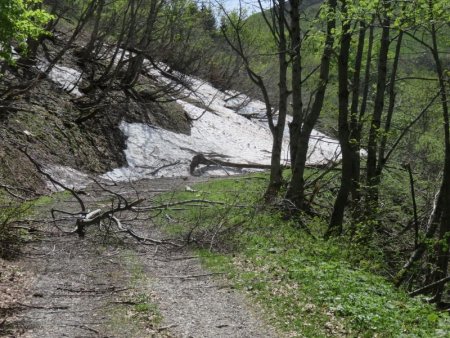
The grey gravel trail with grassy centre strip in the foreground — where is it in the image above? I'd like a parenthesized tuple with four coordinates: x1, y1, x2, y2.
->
(0, 179, 276, 337)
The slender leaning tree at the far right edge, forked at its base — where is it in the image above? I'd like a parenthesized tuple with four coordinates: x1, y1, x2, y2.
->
(396, 0, 450, 304)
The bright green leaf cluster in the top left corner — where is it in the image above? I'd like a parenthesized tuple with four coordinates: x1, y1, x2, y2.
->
(0, 0, 52, 62)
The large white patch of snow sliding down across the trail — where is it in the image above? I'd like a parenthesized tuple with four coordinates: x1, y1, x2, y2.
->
(103, 64, 340, 181)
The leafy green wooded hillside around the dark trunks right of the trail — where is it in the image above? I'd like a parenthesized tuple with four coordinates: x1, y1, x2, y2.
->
(220, 1, 450, 303)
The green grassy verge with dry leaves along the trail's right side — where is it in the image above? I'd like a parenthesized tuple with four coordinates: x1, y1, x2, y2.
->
(161, 175, 450, 337)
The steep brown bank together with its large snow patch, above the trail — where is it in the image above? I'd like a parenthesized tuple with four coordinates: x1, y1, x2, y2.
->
(0, 38, 339, 192)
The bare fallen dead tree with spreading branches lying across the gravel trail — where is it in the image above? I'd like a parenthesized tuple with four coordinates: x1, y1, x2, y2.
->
(16, 148, 250, 247)
